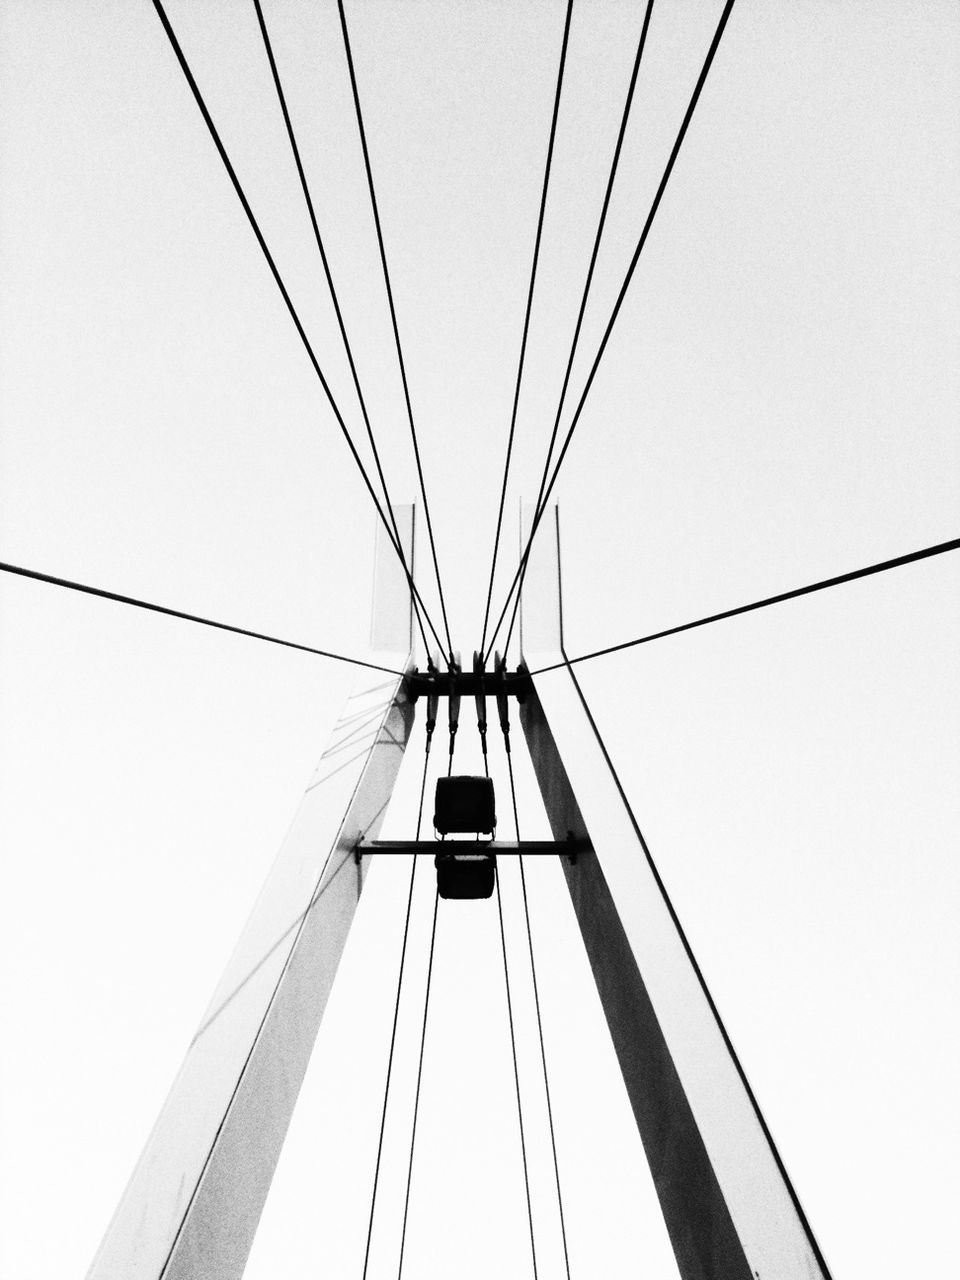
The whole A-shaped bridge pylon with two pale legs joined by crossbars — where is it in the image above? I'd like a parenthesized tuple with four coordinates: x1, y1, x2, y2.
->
(88, 506, 829, 1280)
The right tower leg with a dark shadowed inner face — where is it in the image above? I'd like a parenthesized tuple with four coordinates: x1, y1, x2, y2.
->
(520, 508, 829, 1280)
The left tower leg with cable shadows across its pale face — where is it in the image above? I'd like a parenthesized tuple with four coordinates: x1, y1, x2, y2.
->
(88, 507, 413, 1280)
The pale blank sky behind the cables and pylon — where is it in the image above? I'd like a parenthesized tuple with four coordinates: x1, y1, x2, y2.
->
(0, 0, 960, 1280)
